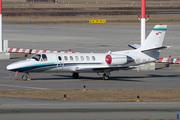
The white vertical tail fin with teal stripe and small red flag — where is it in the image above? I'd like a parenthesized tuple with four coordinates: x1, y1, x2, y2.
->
(139, 25, 167, 51)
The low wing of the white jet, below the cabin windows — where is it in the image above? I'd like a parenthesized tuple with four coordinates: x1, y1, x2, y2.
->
(76, 66, 136, 72)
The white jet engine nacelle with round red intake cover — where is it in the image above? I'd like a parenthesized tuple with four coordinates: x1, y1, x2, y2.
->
(105, 54, 134, 65)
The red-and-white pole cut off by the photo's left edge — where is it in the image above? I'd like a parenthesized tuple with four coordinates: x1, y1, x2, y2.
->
(0, 0, 3, 52)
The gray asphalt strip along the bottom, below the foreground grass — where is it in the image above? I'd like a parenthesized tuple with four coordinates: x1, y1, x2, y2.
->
(0, 98, 180, 120)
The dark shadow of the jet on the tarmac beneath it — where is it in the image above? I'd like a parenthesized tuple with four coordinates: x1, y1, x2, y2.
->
(27, 74, 180, 82)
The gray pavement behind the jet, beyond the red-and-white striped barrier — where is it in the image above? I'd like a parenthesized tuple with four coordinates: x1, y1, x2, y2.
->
(3, 23, 180, 58)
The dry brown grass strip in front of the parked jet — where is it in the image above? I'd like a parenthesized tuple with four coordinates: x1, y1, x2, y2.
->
(0, 89, 180, 102)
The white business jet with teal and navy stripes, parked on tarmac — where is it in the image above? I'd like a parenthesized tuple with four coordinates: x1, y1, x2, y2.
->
(7, 25, 169, 80)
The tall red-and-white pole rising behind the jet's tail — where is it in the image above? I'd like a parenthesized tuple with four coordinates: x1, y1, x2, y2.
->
(141, 0, 146, 45)
